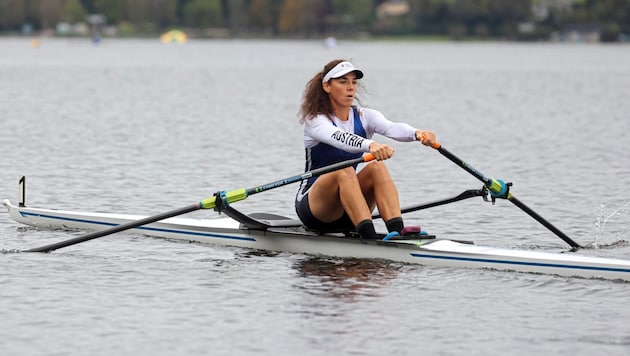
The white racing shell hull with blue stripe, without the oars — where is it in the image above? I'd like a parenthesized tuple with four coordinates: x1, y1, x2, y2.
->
(2, 199, 630, 281)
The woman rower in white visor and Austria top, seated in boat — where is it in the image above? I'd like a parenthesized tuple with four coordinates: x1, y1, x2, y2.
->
(295, 59, 436, 239)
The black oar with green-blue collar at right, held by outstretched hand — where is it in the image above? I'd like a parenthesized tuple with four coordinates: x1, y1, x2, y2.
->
(432, 142, 582, 250)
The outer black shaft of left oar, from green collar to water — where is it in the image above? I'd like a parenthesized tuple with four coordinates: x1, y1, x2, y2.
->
(24, 204, 200, 252)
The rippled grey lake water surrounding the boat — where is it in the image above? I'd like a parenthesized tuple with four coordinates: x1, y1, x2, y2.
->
(0, 38, 630, 356)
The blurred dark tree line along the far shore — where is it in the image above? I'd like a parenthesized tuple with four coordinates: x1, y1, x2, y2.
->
(0, 0, 630, 41)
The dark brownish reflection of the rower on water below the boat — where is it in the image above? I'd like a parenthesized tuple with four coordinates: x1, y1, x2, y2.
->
(296, 257, 400, 301)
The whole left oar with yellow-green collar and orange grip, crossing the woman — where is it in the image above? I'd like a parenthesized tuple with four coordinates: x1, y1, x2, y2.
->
(24, 153, 374, 252)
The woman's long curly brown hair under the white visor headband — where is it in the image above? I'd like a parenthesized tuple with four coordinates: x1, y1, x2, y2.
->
(298, 59, 360, 124)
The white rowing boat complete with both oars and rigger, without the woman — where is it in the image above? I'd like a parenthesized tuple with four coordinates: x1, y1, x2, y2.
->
(2, 147, 630, 281)
